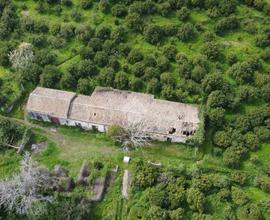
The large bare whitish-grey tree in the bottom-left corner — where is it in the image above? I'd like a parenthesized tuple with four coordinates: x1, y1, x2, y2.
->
(0, 153, 54, 215)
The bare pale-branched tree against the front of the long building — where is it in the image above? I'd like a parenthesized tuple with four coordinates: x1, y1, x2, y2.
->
(115, 121, 151, 150)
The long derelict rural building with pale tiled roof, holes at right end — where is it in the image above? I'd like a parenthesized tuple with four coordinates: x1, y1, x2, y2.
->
(26, 87, 200, 142)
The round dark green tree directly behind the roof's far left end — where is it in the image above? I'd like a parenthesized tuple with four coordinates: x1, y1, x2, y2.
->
(40, 65, 62, 88)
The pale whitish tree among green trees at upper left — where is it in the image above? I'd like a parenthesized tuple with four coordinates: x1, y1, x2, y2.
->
(8, 42, 34, 71)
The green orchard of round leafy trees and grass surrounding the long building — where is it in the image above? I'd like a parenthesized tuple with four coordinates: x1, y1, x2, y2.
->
(0, 0, 270, 219)
